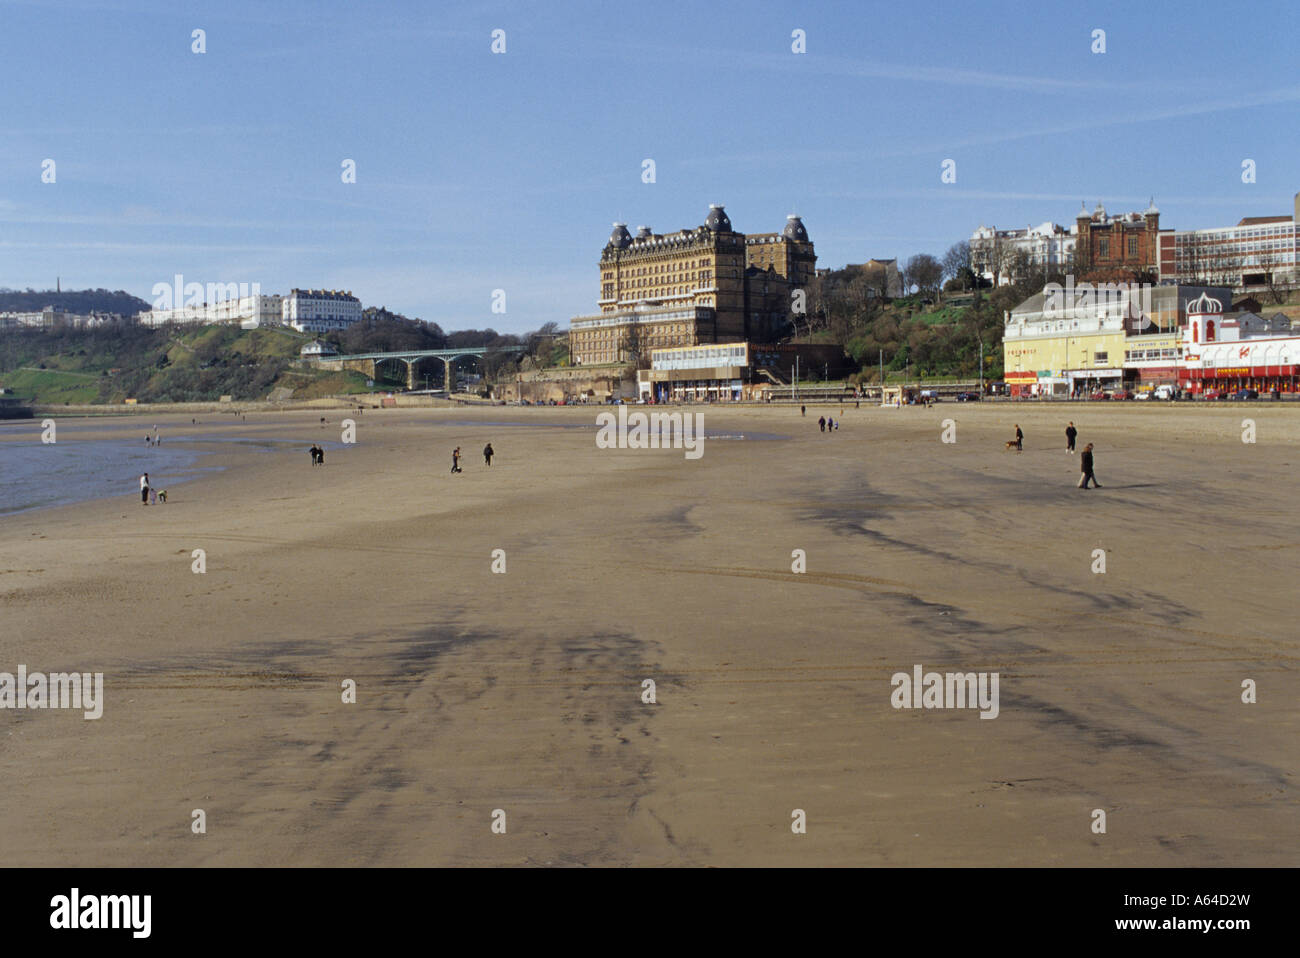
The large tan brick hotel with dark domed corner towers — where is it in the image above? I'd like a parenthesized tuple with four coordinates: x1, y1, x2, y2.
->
(569, 205, 816, 365)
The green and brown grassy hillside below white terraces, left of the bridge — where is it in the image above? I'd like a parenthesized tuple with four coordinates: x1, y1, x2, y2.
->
(0, 326, 367, 403)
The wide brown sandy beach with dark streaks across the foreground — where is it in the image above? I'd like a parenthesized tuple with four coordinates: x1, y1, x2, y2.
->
(0, 403, 1300, 866)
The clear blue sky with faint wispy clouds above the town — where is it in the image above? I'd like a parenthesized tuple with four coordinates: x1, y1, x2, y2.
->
(0, 0, 1300, 331)
